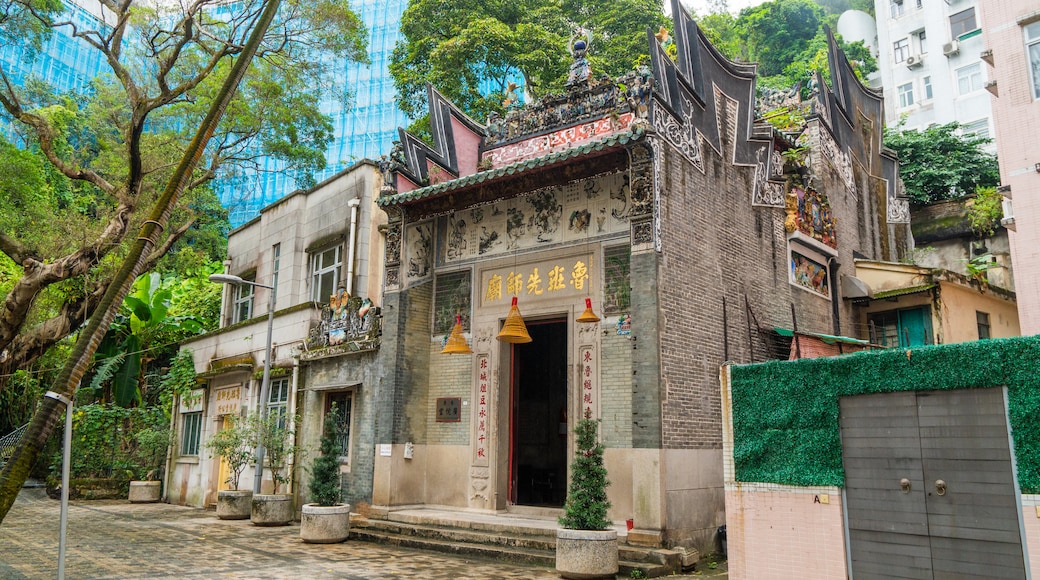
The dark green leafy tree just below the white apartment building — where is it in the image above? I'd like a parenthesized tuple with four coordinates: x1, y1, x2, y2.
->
(884, 123, 1000, 206)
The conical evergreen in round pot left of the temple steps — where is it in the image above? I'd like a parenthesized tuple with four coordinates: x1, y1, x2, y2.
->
(300, 405, 350, 544)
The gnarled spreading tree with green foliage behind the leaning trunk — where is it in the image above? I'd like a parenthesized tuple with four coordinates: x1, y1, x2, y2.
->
(0, 0, 365, 391)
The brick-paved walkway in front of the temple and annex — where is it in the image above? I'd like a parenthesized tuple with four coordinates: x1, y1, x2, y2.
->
(0, 489, 560, 580)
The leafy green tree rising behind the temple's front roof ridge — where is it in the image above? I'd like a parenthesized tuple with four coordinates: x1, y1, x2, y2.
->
(390, 0, 667, 126)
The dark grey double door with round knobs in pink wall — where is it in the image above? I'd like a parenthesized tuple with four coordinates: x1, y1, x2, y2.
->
(839, 389, 1025, 580)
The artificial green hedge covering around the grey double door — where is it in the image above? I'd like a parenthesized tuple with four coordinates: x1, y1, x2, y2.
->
(731, 337, 1040, 494)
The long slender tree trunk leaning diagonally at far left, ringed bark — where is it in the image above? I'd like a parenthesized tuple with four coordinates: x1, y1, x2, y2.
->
(0, 0, 281, 528)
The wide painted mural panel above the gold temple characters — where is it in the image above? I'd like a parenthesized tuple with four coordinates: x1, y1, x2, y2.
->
(434, 172, 634, 265)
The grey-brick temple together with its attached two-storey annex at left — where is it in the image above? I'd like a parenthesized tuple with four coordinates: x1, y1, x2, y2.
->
(167, 1, 912, 551)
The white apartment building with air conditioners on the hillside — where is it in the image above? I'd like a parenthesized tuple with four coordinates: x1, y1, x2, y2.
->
(875, 0, 996, 146)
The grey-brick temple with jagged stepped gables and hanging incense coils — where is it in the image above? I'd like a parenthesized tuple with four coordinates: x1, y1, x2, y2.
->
(366, 2, 912, 549)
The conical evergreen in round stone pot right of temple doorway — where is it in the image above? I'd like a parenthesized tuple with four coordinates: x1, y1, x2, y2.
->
(556, 412, 618, 578)
